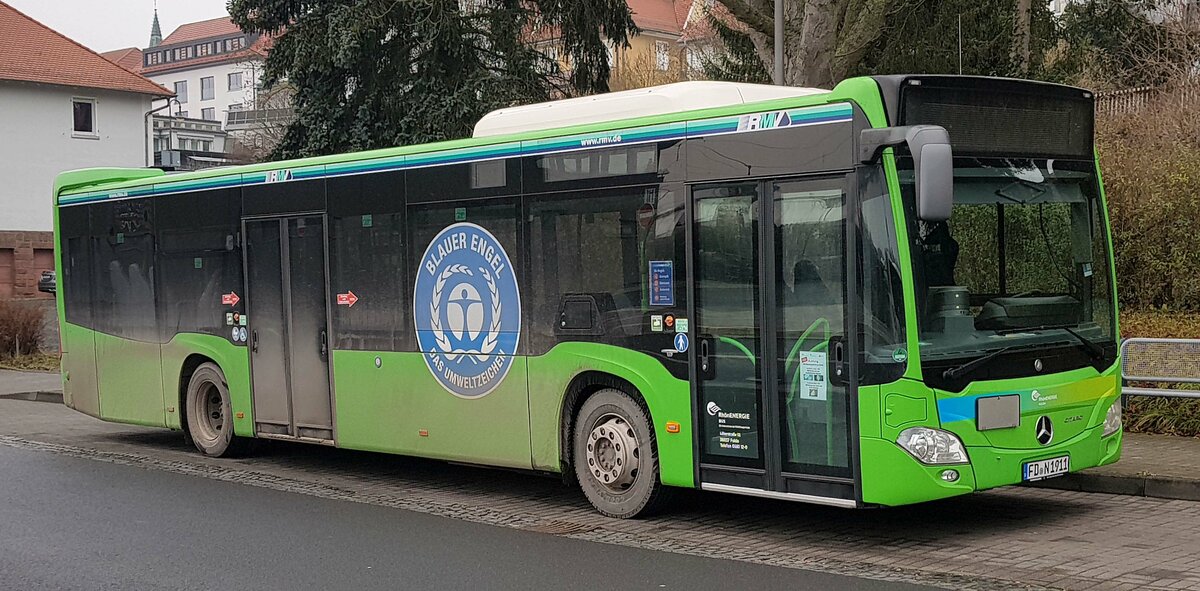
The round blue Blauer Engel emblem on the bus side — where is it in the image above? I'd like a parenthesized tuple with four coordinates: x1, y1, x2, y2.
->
(413, 222, 521, 398)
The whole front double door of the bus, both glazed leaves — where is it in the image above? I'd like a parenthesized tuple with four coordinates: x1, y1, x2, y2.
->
(691, 175, 857, 506)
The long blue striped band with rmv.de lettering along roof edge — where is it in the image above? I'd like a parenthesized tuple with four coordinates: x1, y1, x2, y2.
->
(59, 103, 859, 204)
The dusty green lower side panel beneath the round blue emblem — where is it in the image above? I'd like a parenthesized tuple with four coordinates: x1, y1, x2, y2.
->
(334, 351, 533, 468)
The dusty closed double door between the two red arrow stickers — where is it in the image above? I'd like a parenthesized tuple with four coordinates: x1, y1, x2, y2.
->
(244, 216, 334, 443)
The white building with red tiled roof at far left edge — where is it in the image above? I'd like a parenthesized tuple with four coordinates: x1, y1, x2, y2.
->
(0, 1, 170, 298)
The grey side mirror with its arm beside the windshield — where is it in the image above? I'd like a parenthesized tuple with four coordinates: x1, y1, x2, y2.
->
(858, 125, 954, 222)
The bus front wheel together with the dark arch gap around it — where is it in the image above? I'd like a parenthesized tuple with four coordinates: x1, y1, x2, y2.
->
(562, 372, 664, 518)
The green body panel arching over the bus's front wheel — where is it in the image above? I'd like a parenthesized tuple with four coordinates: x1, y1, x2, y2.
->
(529, 342, 695, 486)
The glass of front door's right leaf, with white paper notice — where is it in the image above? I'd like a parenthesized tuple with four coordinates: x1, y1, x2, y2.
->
(773, 179, 850, 476)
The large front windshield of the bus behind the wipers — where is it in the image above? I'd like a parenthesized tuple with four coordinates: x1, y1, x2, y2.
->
(900, 157, 1114, 372)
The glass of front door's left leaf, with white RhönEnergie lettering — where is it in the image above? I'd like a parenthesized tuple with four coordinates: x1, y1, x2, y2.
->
(692, 183, 763, 467)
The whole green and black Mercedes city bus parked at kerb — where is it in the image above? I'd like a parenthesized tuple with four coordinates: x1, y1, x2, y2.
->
(54, 76, 1122, 517)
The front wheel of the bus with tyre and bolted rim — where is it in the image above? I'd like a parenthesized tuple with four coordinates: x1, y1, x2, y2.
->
(572, 388, 664, 519)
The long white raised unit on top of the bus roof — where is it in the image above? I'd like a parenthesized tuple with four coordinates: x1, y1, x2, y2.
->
(474, 82, 828, 137)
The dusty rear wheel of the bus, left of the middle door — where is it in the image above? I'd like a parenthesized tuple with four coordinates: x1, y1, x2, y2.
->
(185, 363, 245, 458)
